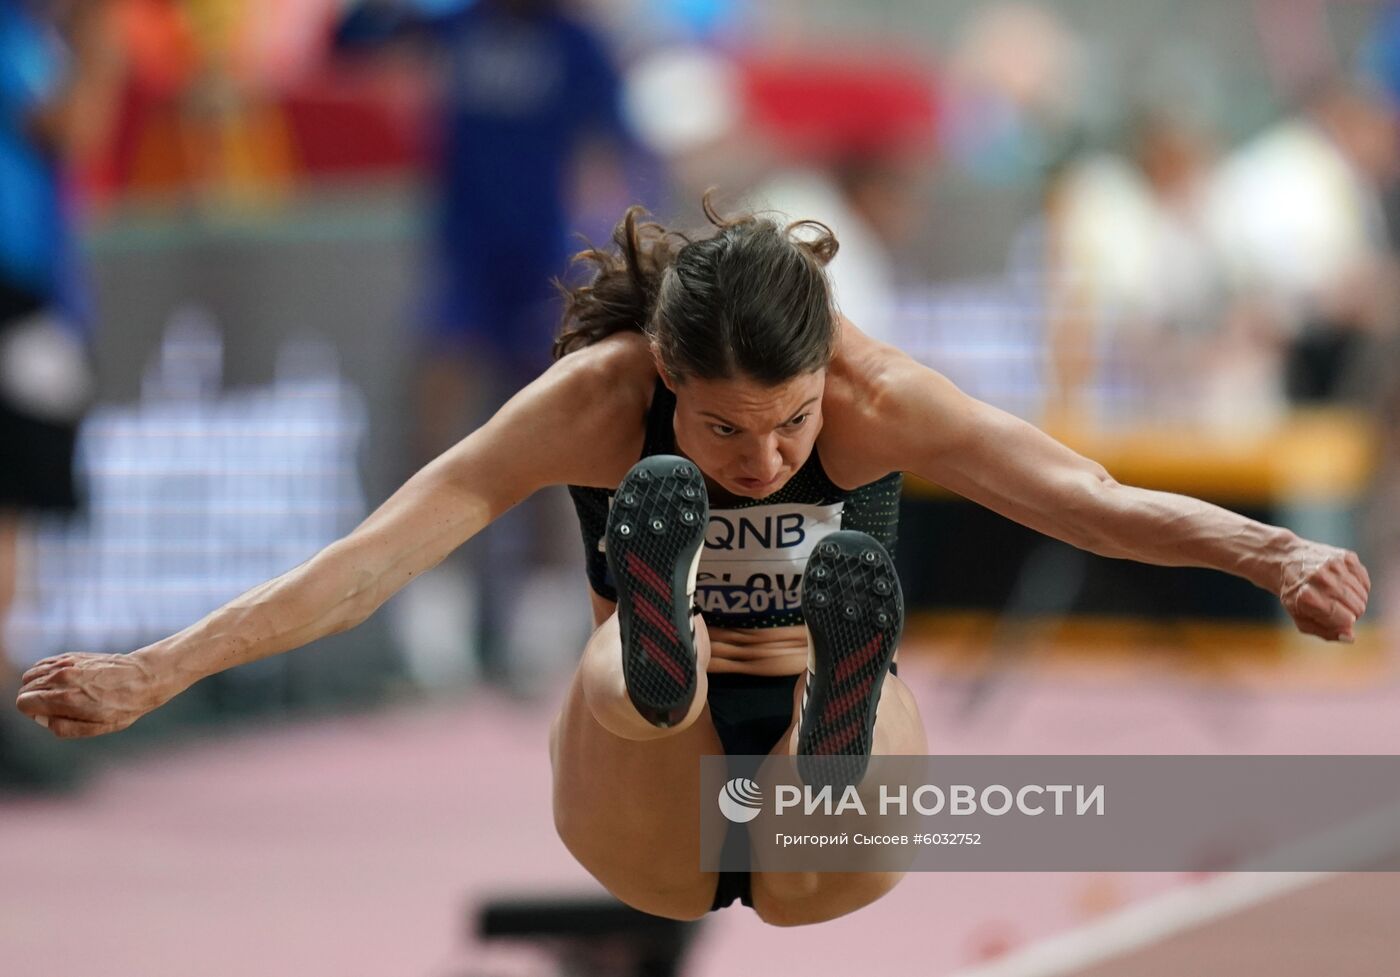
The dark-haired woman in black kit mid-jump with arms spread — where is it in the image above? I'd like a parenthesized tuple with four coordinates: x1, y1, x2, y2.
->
(18, 200, 1371, 924)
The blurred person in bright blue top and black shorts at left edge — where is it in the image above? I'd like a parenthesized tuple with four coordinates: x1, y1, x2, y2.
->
(0, 0, 116, 785)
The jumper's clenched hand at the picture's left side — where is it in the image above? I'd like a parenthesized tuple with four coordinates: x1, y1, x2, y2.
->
(15, 655, 169, 739)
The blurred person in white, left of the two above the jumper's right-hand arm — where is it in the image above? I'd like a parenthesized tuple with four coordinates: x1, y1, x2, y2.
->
(1046, 109, 1282, 428)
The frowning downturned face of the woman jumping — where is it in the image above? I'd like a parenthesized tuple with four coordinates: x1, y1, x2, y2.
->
(666, 370, 826, 498)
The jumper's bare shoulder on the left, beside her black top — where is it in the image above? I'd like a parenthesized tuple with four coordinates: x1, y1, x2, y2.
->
(536, 332, 657, 489)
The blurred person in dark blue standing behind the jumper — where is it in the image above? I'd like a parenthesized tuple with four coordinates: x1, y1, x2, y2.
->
(336, 0, 630, 682)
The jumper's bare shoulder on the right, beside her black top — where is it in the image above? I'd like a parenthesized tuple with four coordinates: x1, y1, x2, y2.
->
(818, 316, 918, 489)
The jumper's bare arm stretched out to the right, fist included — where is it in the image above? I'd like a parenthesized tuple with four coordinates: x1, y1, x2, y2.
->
(869, 351, 1371, 641)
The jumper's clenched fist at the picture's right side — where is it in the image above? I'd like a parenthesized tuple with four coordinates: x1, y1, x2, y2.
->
(1278, 539, 1371, 642)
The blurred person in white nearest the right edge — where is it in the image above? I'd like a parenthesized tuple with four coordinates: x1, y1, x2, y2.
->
(1212, 80, 1400, 403)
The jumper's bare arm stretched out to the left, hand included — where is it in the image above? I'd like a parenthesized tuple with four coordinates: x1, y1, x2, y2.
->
(9, 354, 635, 738)
